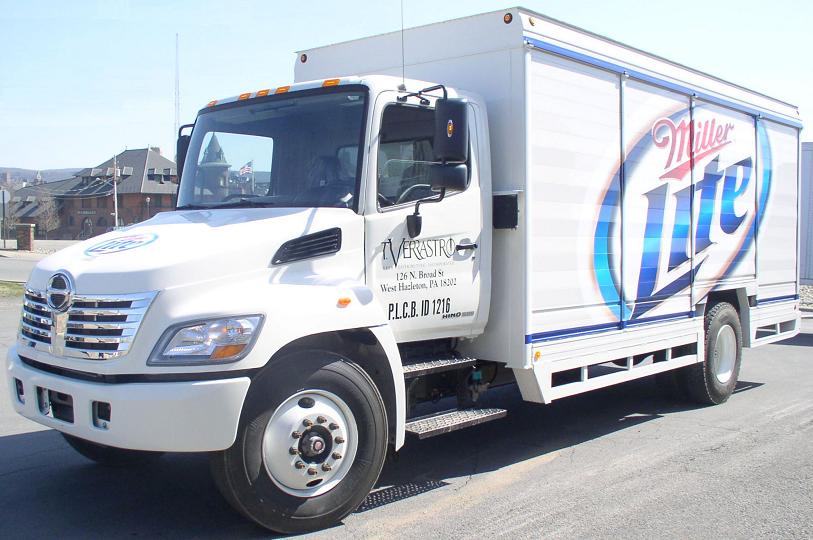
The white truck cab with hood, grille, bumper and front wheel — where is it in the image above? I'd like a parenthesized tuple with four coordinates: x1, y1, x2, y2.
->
(9, 76, 494, 530)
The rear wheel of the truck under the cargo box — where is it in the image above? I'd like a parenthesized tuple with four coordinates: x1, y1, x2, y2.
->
(680, 302, 742, 405)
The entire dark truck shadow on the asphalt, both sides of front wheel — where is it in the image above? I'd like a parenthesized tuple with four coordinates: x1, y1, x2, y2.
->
(0, 380, 761, 538)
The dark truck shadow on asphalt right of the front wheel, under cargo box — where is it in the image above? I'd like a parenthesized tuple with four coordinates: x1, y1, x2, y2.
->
(364, 379, 763, 512)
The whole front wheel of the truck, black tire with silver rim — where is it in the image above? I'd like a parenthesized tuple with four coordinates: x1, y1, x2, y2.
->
(211, 351, 387, 533)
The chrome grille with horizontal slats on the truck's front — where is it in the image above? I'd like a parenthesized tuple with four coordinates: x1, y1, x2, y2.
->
(20, 289, 155, 360)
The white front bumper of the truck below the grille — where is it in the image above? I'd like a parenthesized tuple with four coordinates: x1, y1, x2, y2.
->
(6, 346, 251, 452)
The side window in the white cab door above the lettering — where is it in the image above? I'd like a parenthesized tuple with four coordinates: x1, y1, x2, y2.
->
(378, 105, 435, 208)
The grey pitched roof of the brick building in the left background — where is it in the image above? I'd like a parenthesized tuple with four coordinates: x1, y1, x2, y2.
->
(12, 148, 178, 200)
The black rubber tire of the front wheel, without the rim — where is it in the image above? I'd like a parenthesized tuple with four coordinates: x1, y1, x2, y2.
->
(211, 350, 388, 533)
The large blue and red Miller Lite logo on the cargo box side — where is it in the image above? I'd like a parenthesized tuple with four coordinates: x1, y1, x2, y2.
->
(593, 106, 771, 321)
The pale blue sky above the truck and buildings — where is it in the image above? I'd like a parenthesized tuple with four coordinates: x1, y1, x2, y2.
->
(0, 0, 813, 169)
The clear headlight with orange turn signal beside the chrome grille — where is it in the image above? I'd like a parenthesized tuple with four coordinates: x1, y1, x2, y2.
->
(147, 315, 263, 365)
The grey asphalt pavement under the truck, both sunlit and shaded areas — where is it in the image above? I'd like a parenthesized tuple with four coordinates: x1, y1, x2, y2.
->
(0, 299, 813, 540)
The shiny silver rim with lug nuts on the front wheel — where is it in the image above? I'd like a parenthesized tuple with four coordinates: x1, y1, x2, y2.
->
(262, 390, 358, 497)
